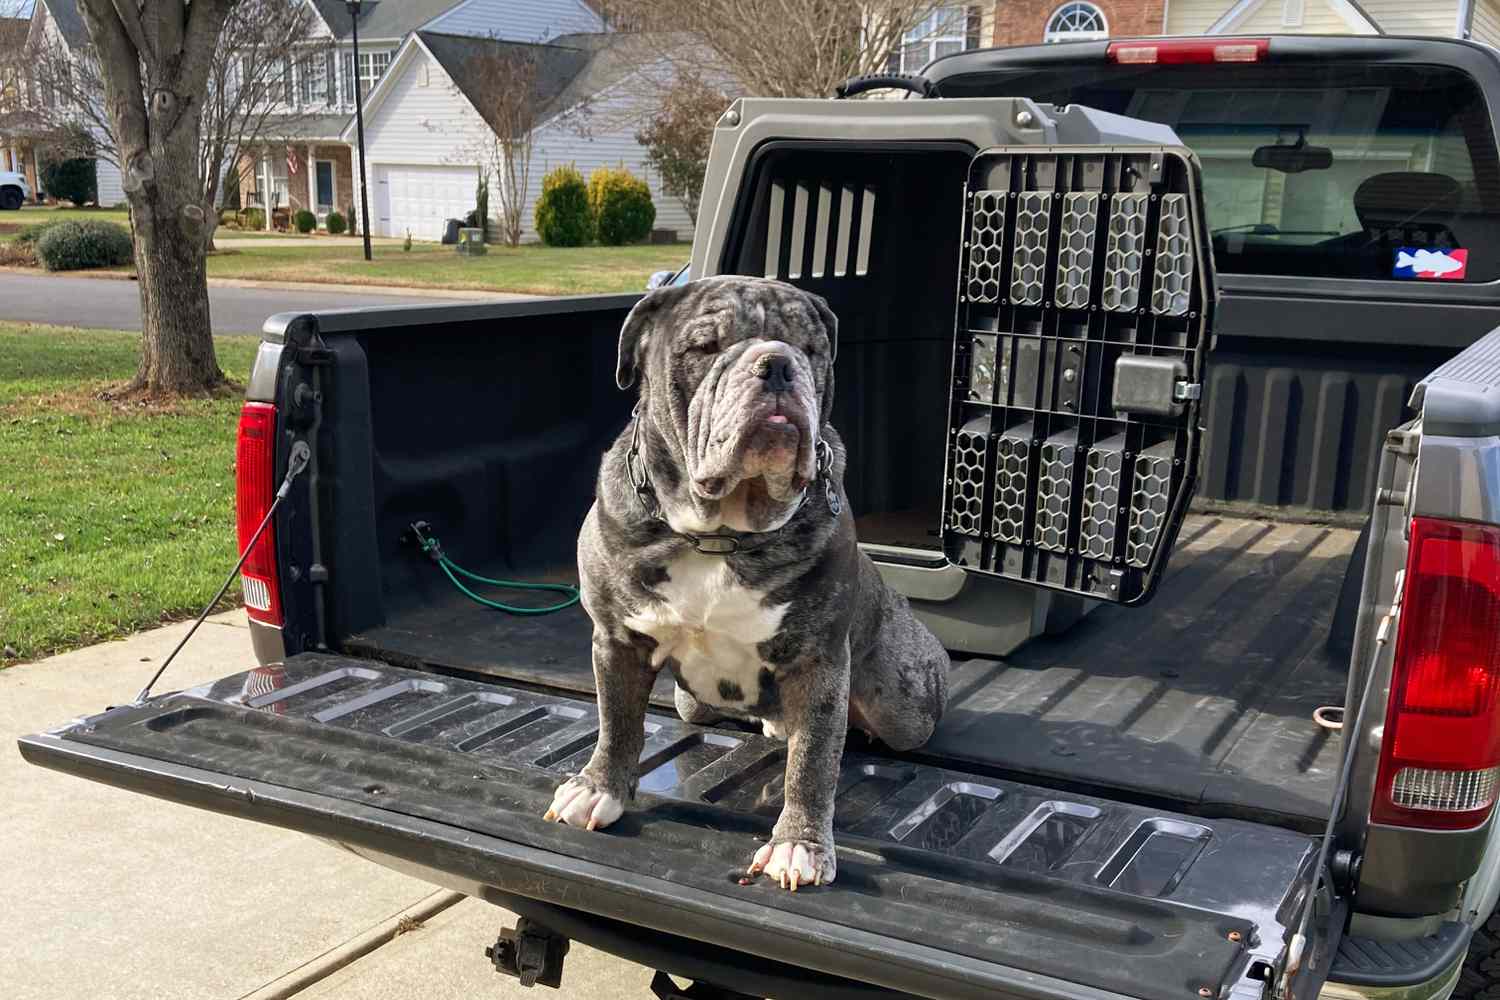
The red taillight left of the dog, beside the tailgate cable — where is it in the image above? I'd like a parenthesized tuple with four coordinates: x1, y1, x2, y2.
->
(234, 403, 282, 625)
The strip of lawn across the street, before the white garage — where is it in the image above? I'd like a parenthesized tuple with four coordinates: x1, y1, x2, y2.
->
(209, 240, 692, 295)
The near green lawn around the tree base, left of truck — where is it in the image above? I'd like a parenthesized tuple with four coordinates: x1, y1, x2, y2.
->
(0, 322, 257, 666)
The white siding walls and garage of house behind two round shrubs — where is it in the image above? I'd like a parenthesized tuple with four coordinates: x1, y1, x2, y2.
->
(345, 32, 693, 240)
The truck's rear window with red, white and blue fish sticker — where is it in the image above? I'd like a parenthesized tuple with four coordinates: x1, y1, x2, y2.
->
(944, 63, 1500, 282)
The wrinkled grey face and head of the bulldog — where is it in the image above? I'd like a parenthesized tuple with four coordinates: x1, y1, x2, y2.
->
(620, 277, 837, 531)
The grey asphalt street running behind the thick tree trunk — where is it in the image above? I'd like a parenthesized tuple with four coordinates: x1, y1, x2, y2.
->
(0, 273, 488, 333)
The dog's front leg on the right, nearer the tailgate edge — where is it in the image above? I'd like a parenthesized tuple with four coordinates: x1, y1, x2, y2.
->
(750, 642, 849, 892)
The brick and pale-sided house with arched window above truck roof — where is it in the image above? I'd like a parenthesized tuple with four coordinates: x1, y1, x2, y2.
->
(987, 0, 1500, 45)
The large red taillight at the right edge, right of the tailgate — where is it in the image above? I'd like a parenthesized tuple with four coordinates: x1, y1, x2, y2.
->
(1371, 517, 1500, 829)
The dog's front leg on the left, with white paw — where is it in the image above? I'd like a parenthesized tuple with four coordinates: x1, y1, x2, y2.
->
(545, 628, 656, 829)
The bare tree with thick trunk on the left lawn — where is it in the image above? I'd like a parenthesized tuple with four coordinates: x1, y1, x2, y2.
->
(0, 0, 332, 394)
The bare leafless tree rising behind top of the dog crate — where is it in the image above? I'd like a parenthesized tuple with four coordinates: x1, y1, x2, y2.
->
(606, 0, 968, 97)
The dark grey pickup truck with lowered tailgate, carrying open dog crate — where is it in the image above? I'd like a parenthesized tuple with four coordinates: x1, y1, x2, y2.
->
(21, 31, 1500, 1000)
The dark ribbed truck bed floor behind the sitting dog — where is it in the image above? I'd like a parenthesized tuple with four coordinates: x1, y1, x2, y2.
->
(345, 514, 1358, 831)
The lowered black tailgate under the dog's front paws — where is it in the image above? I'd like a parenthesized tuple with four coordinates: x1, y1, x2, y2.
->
(23, 654, 1313, 997)
